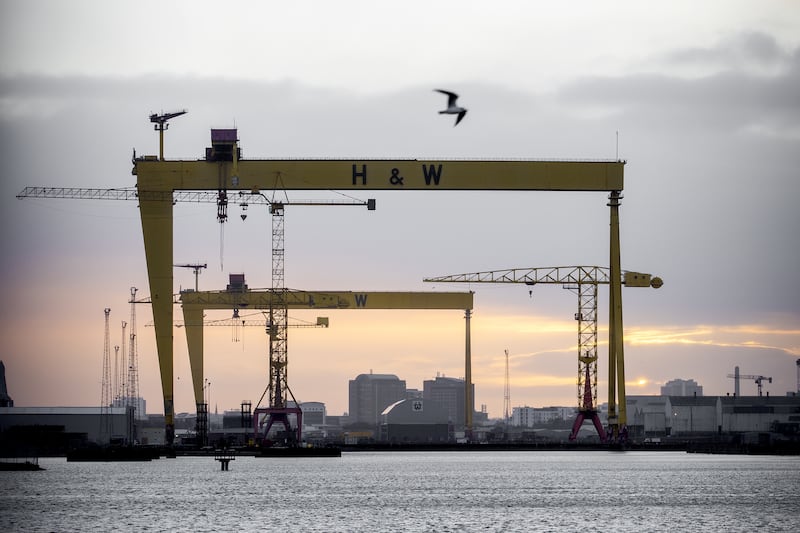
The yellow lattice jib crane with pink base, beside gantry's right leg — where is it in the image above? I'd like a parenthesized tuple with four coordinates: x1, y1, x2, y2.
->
(423, 266, 663, 441)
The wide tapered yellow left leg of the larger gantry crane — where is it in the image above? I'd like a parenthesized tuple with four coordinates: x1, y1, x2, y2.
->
(139, 198, 175, 446)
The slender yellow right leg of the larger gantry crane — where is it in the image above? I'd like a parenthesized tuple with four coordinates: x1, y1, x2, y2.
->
(608, 191, 628, 439)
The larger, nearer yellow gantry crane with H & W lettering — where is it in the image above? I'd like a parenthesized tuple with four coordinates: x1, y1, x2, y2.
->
(18, 117, 625, 445)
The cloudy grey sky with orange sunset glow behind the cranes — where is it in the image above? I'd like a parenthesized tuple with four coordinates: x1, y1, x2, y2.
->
(0, 1, 800, 416)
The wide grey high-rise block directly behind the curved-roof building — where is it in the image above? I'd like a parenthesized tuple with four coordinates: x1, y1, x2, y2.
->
(348, 374, 406, 426)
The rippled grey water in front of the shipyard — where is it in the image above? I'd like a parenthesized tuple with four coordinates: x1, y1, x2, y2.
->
(0, 452, 800, 532)
